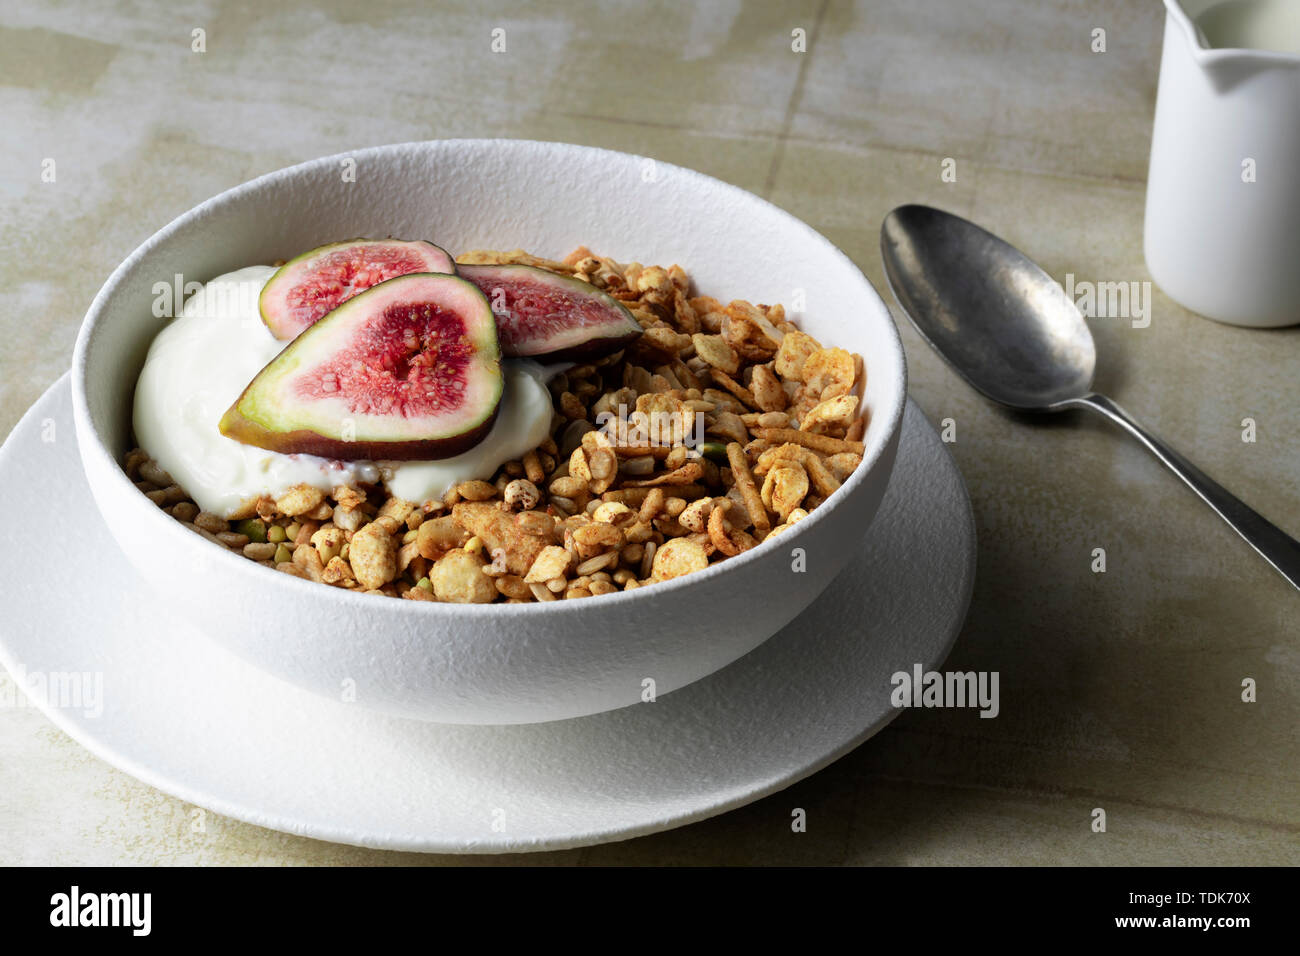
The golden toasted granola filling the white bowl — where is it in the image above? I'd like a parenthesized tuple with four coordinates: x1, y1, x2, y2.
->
(125, 247, 867, 604)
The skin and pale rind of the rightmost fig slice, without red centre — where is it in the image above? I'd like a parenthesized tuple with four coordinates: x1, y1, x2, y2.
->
(458, 263, 641, 363)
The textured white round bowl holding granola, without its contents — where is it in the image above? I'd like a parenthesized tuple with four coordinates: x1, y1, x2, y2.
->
(73, 139, 906, 723)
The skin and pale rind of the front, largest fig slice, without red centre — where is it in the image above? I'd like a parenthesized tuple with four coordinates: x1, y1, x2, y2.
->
(218, 273, 504, 460)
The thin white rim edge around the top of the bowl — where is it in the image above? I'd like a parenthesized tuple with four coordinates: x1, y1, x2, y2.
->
(72, 137, 907, 618)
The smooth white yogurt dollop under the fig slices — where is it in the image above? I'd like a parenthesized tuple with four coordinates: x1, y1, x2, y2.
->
(133, 265, 554, 516)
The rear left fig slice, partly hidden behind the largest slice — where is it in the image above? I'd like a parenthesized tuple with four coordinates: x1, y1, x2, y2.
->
(257, 239, 456, 342)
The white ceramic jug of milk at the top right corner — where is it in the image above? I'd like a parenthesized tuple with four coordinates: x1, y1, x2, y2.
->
(1145, 0, 1300, 326)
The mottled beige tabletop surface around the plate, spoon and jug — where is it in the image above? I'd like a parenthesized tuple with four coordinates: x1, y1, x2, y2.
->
(0, 0, 1300, 864)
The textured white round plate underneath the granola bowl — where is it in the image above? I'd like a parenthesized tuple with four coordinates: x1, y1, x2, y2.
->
(0, 376, 975, 853)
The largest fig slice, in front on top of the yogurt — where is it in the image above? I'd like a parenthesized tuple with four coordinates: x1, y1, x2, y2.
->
(220, 273, 503, 460)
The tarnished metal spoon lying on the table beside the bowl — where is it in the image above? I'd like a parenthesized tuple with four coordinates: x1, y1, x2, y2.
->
(880, 206, 1300, 588)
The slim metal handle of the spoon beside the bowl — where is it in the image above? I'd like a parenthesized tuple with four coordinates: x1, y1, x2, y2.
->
(1062, 393, 1300, 588)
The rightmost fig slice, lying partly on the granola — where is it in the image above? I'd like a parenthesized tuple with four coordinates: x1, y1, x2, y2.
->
(458, 264, 641, 362)
